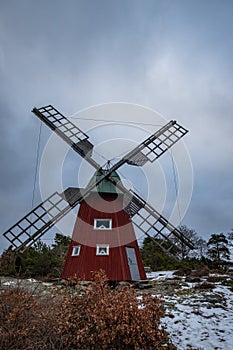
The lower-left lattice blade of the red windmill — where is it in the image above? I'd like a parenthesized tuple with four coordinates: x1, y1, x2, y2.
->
(3, 188, 83, 251)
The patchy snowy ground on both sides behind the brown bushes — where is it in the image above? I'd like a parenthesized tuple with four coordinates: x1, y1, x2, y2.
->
(0, 271, 233, 350)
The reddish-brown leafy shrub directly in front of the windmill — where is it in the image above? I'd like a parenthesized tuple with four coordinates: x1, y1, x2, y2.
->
(56, 272, 174, 350)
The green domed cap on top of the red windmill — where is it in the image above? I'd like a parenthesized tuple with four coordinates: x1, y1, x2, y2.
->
(88, 170, 122, 194)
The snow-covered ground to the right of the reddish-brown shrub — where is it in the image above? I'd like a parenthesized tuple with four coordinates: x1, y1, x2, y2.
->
(148, 271, 233, 350)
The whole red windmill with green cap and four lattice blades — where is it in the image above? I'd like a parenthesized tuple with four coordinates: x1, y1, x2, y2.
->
(3, 105, 194, 281)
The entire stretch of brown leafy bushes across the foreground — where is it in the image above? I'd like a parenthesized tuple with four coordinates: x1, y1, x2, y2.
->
(0, 272, 175, 350)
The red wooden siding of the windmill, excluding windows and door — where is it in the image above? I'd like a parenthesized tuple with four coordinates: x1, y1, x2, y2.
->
(62, 193, 146, 281)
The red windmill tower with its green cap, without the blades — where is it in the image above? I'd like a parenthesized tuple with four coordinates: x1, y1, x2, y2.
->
(62, 172, 146, 281)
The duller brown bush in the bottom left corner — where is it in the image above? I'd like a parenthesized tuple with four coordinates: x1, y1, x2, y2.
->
(0, 287, 60, 350)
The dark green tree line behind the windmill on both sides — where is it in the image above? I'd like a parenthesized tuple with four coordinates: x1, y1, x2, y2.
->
(0, 225, 233, 278)
